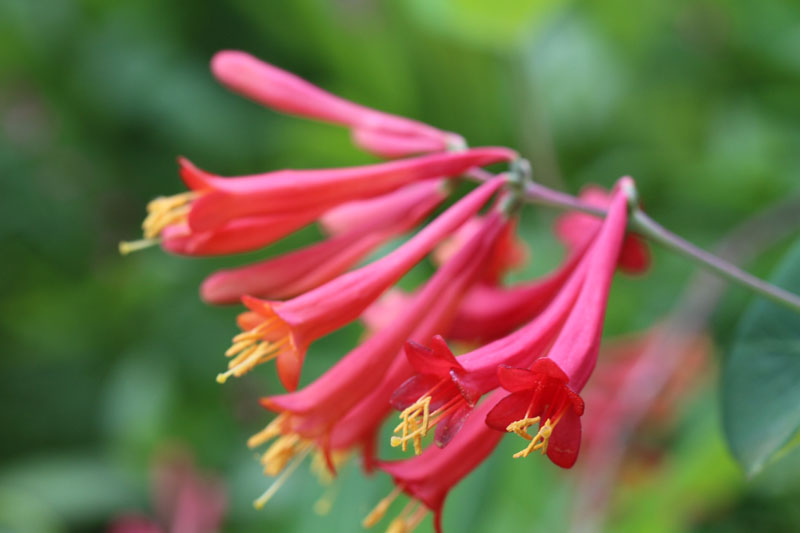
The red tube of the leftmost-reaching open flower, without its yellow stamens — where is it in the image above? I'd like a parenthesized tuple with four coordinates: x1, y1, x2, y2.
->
(181, 147, 516, 231)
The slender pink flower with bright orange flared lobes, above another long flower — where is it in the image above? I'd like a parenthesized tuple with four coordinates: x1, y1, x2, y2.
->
(217, 177, 505, 390)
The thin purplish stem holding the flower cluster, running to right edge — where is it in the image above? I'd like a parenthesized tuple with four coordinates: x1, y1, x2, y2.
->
(516, 181, 800, 312)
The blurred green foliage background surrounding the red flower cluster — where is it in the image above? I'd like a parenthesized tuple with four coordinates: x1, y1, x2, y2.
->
(0, 0, 800, 533)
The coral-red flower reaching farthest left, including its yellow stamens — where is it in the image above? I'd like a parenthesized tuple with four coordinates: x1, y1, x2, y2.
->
(120, 147, 515, 255)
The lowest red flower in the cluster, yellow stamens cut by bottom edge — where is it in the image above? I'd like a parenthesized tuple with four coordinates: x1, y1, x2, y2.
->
(363, 391, 502, 533)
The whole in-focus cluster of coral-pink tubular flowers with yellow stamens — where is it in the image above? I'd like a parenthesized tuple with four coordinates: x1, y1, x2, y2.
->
(121, 51, 649, 531)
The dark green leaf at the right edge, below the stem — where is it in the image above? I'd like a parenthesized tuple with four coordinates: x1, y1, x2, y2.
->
(722, 237, 800, 476)
